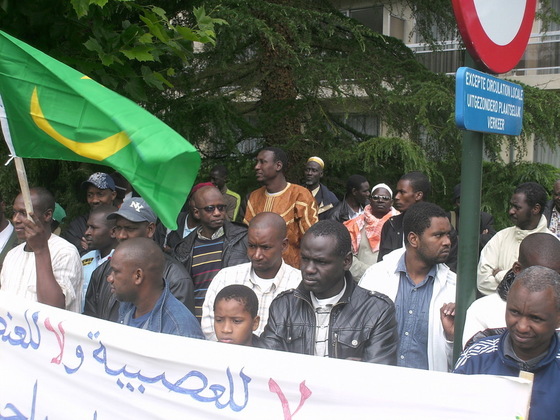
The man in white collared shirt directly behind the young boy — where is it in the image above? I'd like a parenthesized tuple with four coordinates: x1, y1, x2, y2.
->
(201, 212, 301, 340)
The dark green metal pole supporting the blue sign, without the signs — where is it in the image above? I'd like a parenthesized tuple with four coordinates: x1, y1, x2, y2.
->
(453, 53, 484, 362)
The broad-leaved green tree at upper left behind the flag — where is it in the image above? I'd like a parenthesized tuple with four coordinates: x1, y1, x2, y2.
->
(0, 0, 224, 214)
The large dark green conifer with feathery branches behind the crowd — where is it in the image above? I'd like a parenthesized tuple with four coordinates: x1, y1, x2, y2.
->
(156, 0, 559, 203)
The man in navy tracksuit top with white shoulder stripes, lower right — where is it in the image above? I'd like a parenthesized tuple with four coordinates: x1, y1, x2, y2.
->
(454, 266, 560, 419)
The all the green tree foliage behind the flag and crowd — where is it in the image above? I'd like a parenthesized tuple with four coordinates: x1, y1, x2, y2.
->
(0, 0, 560, 230)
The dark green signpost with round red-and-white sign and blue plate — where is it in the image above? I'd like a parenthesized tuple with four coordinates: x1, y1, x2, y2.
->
(452, 0, 537, 361)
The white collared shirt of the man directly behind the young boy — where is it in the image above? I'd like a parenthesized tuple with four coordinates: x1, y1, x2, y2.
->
(201, 261, 301, 341)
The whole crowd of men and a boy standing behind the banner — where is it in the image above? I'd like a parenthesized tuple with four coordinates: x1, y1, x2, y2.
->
(0, 147, 560, 418)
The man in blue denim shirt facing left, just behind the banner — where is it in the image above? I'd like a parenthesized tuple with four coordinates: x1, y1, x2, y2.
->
(107, 238, 204, 339)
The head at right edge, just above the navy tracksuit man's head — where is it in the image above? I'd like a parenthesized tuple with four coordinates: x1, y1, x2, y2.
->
(518, 232, 560, 273)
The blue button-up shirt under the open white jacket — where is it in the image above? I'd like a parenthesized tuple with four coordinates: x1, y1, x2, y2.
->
(395, 254, 436, 369)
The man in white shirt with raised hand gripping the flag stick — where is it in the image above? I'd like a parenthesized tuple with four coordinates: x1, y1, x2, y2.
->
(0, 188, 83, 312)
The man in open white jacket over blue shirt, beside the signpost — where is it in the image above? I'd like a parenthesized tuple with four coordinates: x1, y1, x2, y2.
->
(360, 202, 456, 372)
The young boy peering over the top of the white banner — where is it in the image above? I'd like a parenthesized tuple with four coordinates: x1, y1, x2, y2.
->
(214, 284, 260, 347)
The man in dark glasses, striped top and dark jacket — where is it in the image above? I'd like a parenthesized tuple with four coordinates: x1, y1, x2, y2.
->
(174, 186, 248, 321)
